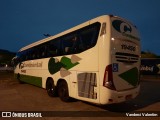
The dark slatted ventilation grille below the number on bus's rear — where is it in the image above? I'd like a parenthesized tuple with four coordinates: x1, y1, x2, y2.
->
(115, 52, 139, 63)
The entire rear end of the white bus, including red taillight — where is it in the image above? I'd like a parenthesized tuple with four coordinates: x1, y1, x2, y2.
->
(103, 16, 141, 104)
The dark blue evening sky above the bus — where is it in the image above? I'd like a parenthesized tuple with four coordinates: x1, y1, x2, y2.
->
(0, 0, 160, 55)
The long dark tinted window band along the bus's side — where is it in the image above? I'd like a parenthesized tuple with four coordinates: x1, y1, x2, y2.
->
(17, 22, 100, 62)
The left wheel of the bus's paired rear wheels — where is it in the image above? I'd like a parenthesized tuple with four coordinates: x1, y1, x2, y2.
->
(46, 79, 57, 97)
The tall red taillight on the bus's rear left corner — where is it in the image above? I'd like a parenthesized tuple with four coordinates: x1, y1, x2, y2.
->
(103, 65, 116, 90)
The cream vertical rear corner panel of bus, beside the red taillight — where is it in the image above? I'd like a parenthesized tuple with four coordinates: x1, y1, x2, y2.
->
(98, 17, 112, 104)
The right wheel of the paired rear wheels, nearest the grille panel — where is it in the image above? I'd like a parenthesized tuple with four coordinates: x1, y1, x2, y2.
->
(58, 81, 70, 102)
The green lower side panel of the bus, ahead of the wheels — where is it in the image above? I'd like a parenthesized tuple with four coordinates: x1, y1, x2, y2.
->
(20, 75, 42, 87)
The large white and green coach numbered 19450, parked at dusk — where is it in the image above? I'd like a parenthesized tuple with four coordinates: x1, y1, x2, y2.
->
(14, 15, 141, 105)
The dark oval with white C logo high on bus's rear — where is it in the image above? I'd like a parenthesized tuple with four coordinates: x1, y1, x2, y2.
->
(112, 20, 132, 33)
